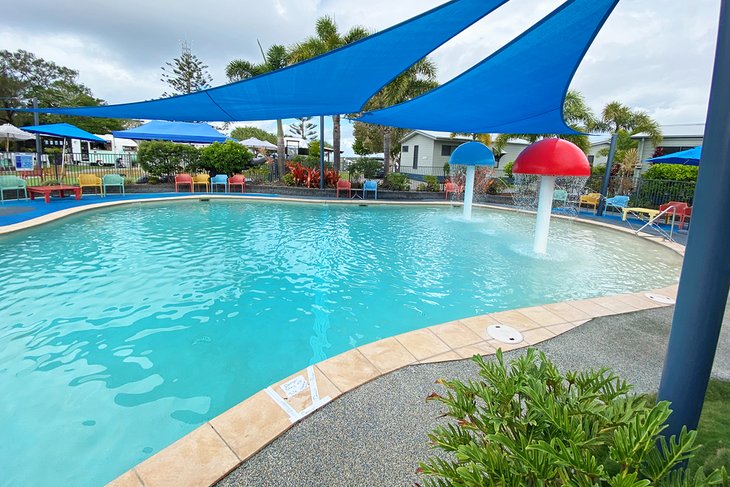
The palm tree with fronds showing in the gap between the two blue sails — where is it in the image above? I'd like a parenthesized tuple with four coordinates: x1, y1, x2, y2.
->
(365, 58, 438, 174)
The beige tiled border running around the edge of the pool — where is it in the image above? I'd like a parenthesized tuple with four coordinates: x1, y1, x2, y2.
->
(0, 193, 683, 487)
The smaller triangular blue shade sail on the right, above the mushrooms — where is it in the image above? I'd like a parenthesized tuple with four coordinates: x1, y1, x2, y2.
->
(358, 0, 618, 134)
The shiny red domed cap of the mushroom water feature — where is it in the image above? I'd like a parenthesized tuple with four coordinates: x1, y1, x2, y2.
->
(512, 138, 591, 177)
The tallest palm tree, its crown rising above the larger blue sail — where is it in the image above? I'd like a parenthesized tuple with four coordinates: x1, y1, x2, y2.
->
(289, 15, 370, 171)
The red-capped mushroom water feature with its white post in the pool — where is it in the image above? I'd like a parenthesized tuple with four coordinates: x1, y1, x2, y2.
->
(512, 139, 591, 254)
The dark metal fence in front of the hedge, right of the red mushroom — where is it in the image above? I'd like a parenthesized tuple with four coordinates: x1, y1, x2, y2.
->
(586, 176, 695, 208)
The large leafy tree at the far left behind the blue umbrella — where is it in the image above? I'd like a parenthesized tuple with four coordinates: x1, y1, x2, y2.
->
(0, 50, 128, 134)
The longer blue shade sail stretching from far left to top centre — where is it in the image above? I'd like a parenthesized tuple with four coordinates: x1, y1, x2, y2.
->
(18, 0, 507, 121)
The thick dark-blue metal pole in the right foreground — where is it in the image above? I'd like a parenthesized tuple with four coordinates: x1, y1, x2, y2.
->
(659, 0, 730, 436)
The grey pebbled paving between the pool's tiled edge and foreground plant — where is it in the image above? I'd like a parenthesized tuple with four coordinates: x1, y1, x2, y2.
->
(218, 307, 730, 487)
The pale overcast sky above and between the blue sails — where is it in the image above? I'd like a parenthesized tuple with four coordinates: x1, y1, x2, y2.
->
(0, 0, 720, 154)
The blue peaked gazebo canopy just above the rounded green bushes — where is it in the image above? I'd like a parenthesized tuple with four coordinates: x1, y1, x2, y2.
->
(112, 120, 228, 144)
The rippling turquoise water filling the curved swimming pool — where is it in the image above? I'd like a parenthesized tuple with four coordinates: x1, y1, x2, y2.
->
(0, 201, 680, 486)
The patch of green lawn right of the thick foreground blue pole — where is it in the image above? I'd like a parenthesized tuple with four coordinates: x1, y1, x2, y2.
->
(690, 379, 730, 472)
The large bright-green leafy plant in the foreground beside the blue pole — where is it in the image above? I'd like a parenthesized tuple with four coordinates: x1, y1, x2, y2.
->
(418, 349, 730, 487)
